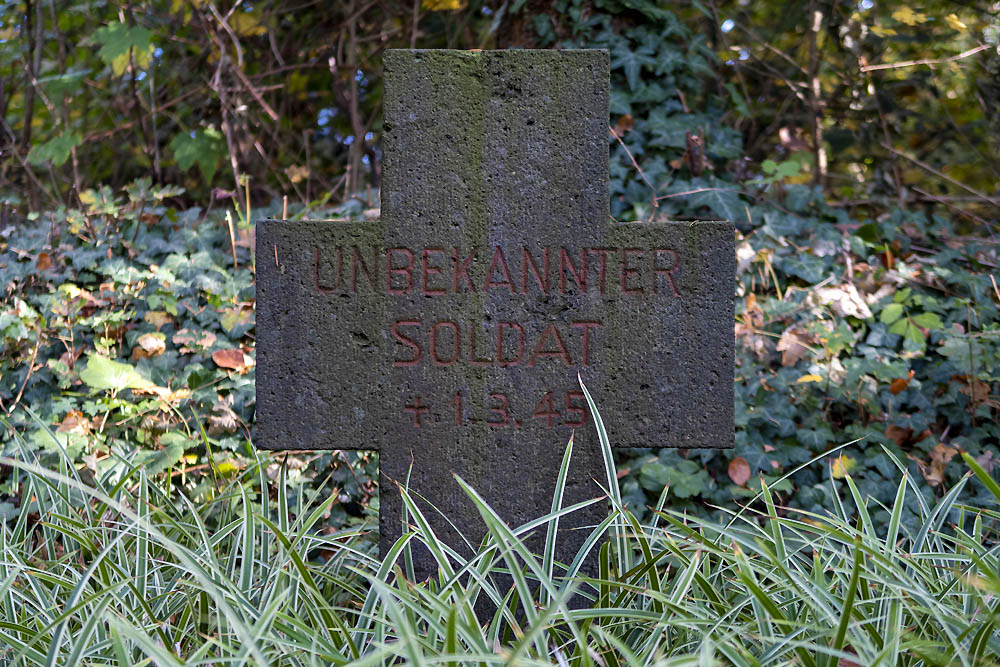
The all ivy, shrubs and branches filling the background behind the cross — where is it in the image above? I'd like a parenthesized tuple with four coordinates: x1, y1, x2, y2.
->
(0, 0, 1000, 540)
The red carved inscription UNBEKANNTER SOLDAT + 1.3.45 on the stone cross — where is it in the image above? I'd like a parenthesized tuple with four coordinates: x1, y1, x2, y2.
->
(312, 245, 681, 429)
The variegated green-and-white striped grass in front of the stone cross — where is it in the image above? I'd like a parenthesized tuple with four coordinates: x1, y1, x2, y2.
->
(0, 388, 1000, 667)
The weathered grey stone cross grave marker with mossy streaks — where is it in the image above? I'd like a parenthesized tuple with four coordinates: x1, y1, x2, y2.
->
(255, 50, 735, 576)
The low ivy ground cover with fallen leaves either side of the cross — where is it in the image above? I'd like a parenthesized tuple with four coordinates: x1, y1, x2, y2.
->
(0, 182, 1000, 544)
